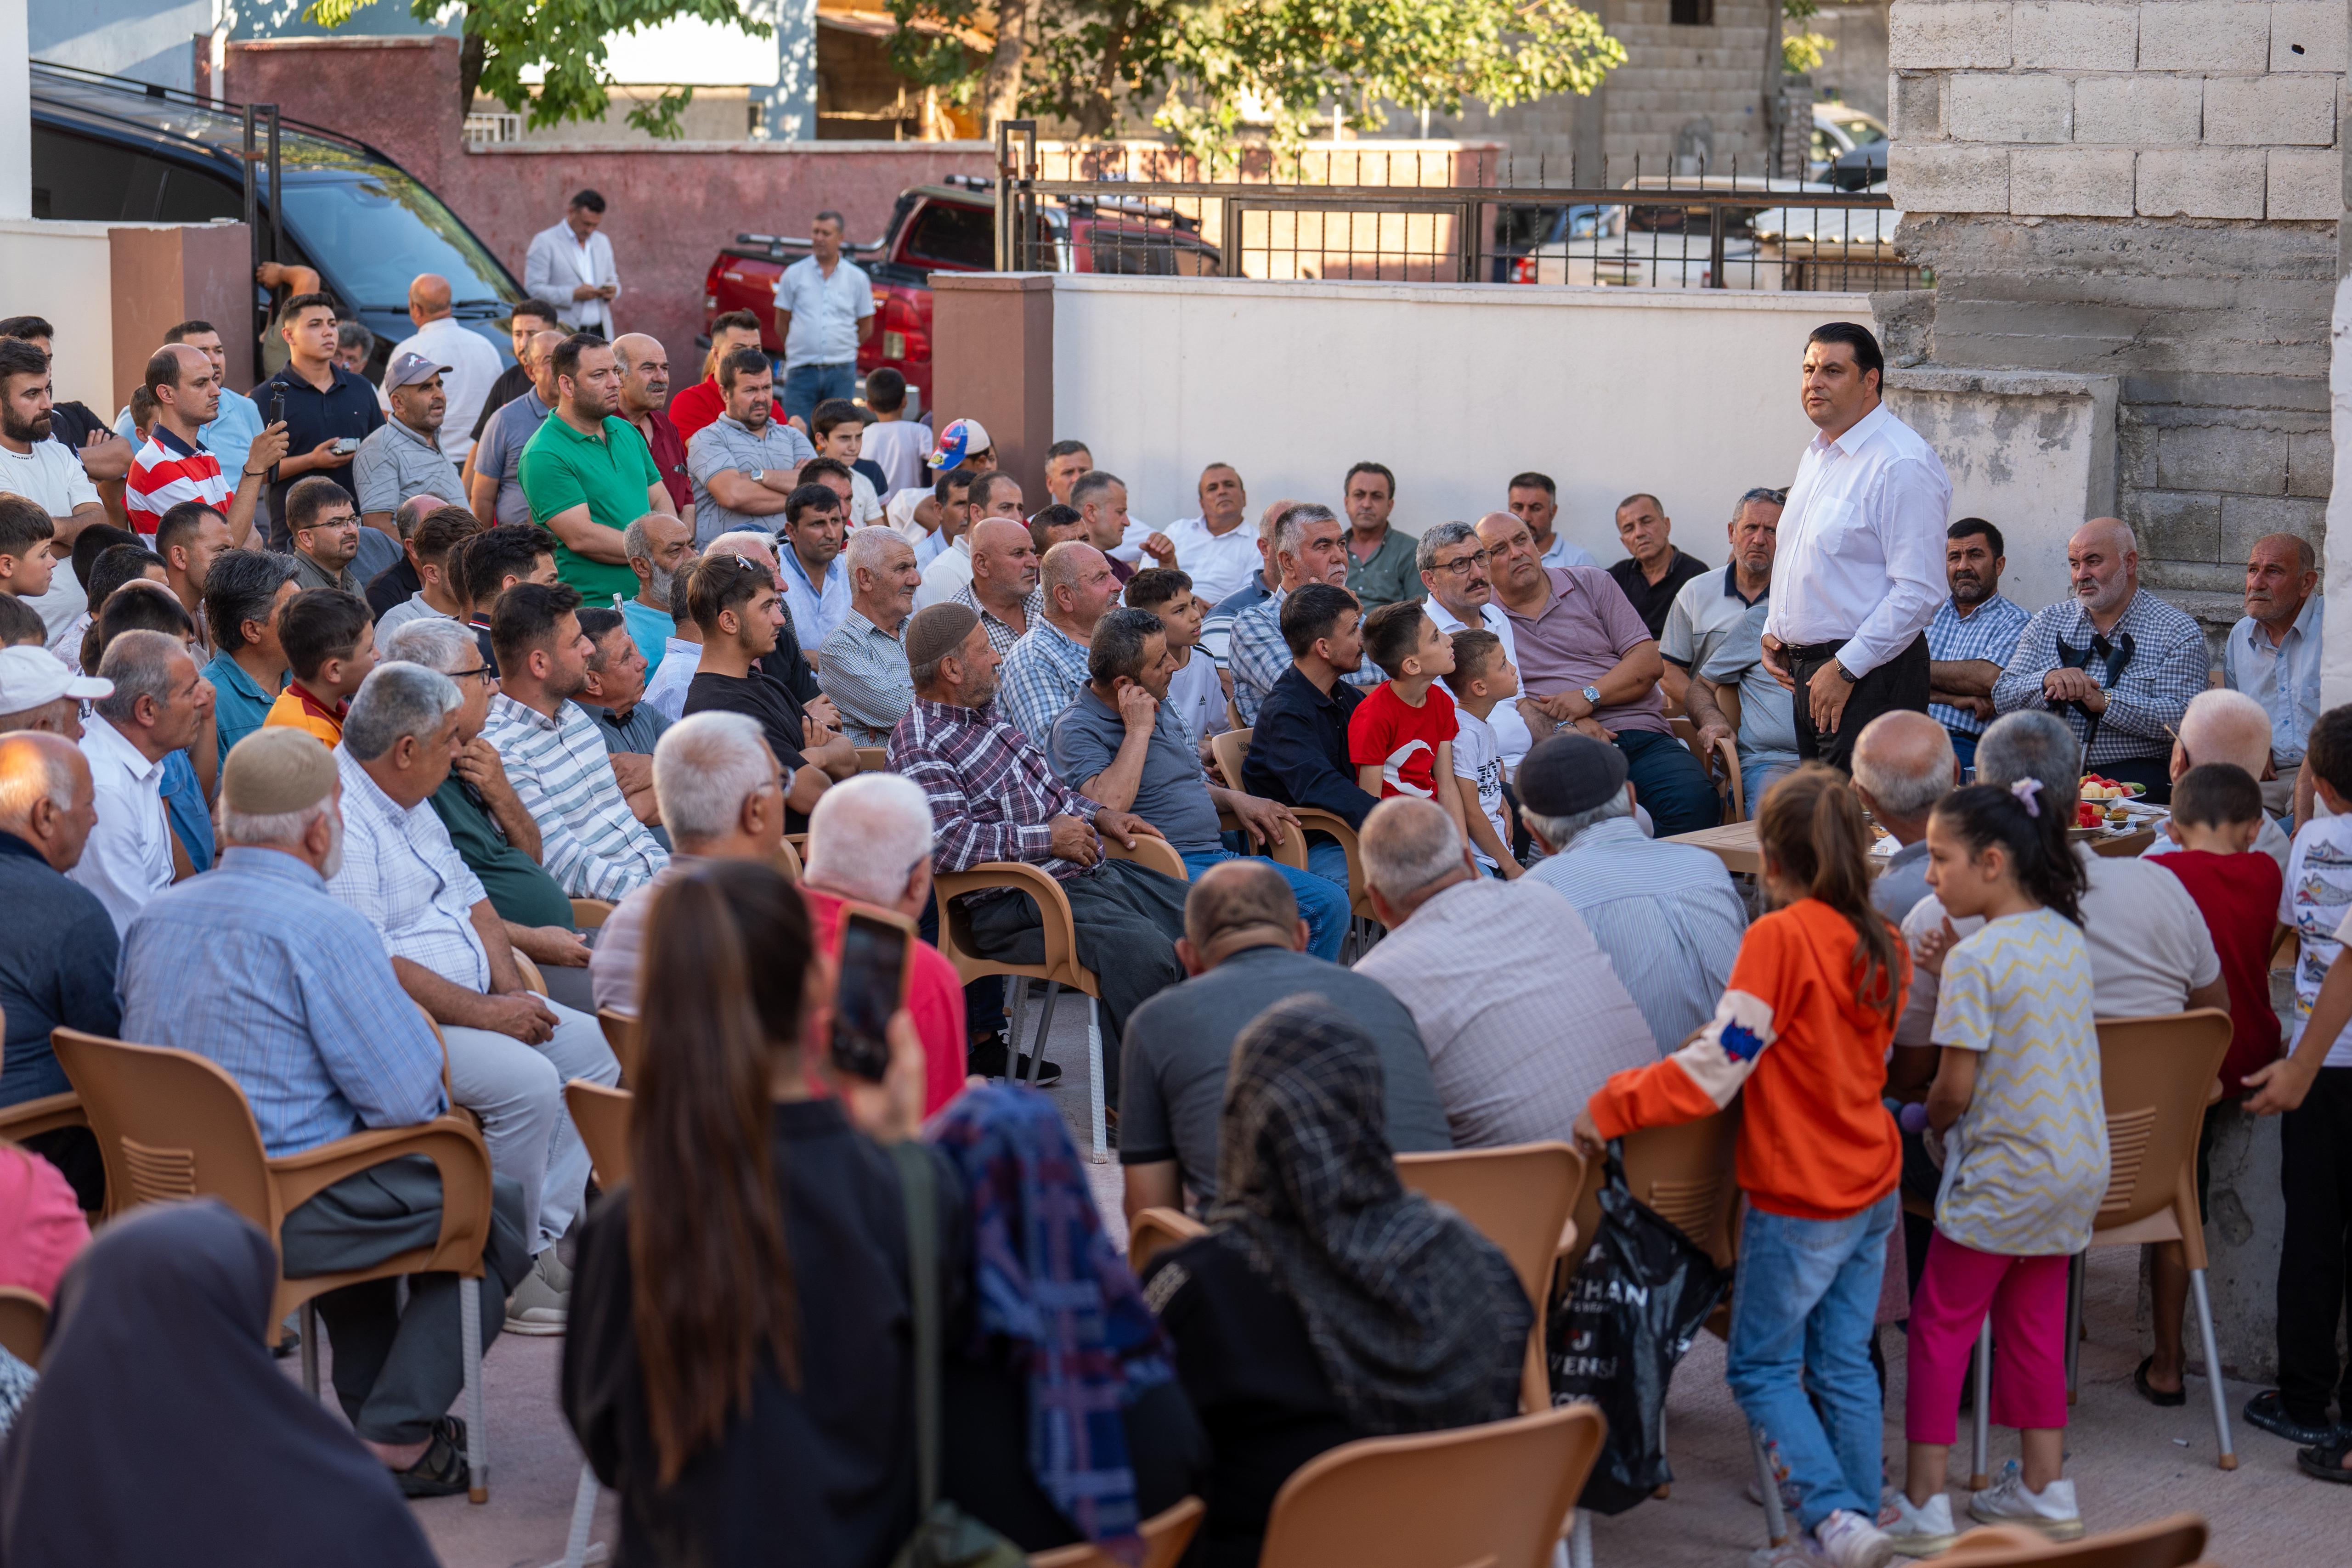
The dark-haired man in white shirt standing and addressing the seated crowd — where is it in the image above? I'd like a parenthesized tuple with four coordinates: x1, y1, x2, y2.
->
(1764, 322, 1952, 769)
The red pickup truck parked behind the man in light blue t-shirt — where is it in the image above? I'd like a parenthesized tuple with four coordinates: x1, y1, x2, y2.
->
(703, 176, 1223, 416)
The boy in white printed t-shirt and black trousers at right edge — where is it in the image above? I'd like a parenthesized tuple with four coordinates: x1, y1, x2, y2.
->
(2246, 708, 2352, 1467)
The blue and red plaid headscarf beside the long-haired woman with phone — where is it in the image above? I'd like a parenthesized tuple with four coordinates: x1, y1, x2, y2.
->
(924, 1084, 1174, 1563)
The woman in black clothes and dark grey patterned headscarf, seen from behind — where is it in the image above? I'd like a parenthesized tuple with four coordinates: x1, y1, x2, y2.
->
(1143, 997, 1533, 1568)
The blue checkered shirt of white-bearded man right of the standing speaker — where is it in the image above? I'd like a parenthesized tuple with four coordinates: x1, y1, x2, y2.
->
(1992, 588, 2213, 769)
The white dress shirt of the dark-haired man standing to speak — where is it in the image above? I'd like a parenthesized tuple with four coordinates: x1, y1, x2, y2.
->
(1764, 404, 1952, 677)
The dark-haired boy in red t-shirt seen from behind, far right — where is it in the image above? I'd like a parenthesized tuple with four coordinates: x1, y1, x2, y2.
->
(2131, 761, 2284, 1406)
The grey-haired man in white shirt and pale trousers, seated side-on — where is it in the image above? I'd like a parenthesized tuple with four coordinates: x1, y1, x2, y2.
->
(327, 663, 621, 1333)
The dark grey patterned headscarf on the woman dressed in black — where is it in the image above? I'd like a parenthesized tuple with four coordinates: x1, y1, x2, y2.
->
(1209, 997, 1533, 1434)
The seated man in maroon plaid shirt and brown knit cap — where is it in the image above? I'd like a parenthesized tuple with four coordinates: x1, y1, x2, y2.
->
(889, 602, 1188, 1105)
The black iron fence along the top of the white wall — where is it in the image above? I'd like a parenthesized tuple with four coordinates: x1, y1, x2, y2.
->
(995, 120, 1934, 292)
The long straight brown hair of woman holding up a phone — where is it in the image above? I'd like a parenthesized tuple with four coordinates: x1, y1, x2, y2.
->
(628, 860, 809, 1486)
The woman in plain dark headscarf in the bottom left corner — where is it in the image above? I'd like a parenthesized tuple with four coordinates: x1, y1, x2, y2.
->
(0, 1199, 433, 1568)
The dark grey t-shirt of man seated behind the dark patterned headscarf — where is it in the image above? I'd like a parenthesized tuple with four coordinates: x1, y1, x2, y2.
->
(1119, 948, 1453, 1204)
